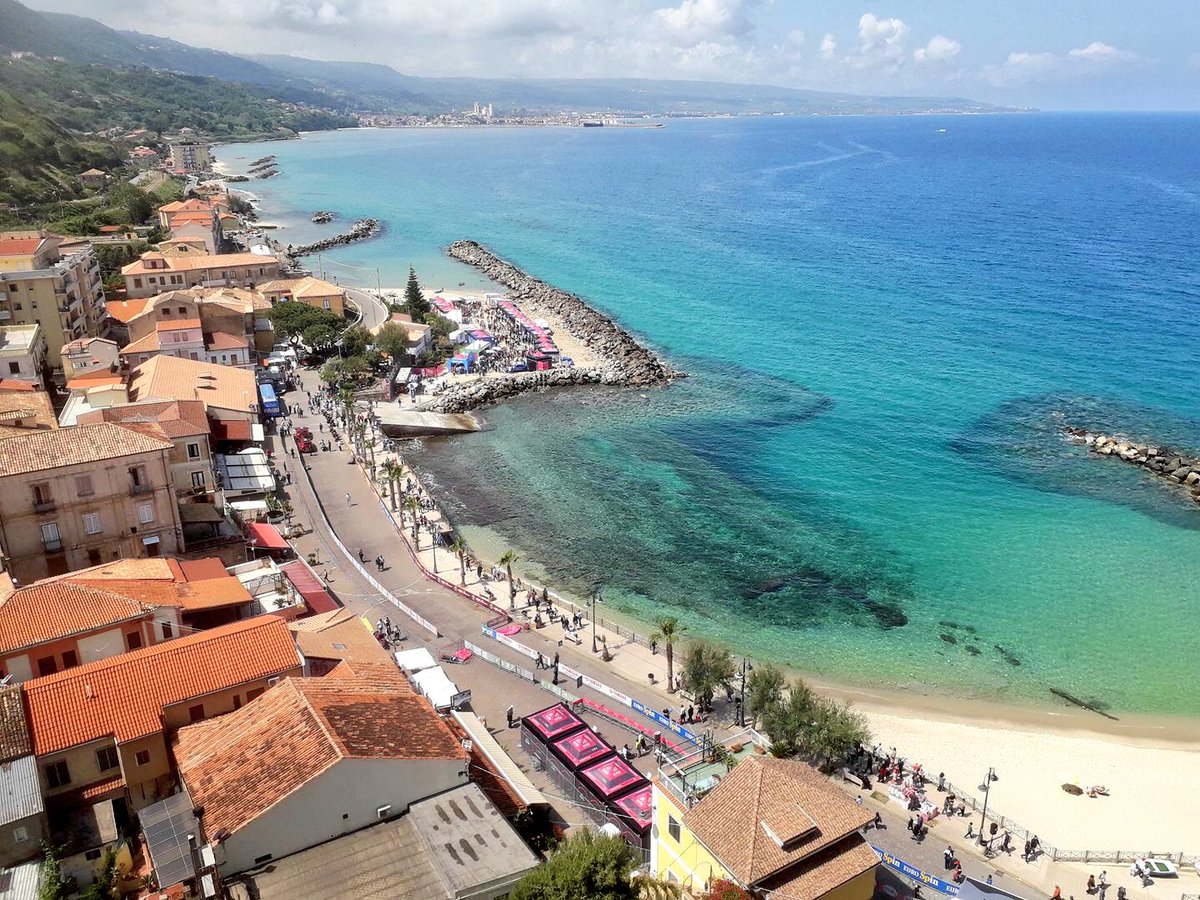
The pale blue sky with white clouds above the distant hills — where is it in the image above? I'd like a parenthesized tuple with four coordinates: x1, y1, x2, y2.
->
(30, 0, 1200, 109)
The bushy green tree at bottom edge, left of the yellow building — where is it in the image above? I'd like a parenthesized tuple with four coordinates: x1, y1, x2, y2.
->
(512, 832, 637, 900)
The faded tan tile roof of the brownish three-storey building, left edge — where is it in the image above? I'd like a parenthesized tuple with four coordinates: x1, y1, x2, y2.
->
(0, 422, 171, 478)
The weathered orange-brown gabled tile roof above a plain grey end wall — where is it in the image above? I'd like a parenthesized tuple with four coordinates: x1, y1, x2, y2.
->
(174, 678, 467, 834)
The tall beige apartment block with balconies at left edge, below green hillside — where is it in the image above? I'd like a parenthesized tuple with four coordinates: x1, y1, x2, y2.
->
(0, 232, 106, 368)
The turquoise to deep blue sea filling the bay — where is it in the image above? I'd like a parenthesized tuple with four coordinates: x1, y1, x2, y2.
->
(220, 115, 1200, 715)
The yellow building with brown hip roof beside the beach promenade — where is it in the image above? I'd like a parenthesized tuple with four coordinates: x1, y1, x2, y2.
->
(650, 754, 878, 900)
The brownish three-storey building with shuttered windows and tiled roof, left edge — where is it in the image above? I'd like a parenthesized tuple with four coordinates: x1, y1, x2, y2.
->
(0, 422, 180, 583)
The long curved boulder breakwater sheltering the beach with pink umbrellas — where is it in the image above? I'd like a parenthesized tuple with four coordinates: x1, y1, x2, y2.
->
(449, 241, 684, 386)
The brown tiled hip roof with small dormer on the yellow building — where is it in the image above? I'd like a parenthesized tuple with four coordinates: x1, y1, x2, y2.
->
(683, 756, 875, 884)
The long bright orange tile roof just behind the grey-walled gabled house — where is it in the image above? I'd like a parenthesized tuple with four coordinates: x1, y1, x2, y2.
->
(22, 616, 300, 756)
